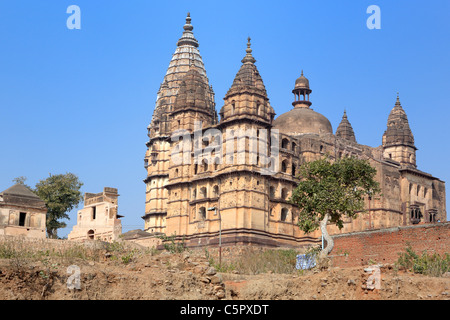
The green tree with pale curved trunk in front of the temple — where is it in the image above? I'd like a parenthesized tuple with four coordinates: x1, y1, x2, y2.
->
(290, 157, 380, 259)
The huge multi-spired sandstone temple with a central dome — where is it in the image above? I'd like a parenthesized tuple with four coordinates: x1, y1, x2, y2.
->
(143, 15, 446, 246)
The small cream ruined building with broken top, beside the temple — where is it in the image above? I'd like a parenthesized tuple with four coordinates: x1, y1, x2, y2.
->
(67, 188, 123, 242)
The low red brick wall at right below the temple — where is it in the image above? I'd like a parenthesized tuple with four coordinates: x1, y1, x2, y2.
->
(330, 222, 450, 267)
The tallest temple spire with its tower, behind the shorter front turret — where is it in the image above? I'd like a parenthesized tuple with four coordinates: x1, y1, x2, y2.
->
(143, 13, 217, 232)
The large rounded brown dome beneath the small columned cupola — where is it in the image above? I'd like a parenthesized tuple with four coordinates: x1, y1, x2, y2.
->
(273, 108, 333, 135)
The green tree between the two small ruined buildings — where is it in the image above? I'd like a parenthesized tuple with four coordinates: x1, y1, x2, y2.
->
(34, 173, 83, 239)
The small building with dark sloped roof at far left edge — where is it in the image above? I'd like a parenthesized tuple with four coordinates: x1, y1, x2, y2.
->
(0, 183, 47, 239)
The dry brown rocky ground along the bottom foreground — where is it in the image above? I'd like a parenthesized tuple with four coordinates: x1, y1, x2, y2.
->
(0, 251, 450, 300)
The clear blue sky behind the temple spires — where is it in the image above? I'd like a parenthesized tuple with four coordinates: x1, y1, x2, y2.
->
(0, 0, 450, 236)
